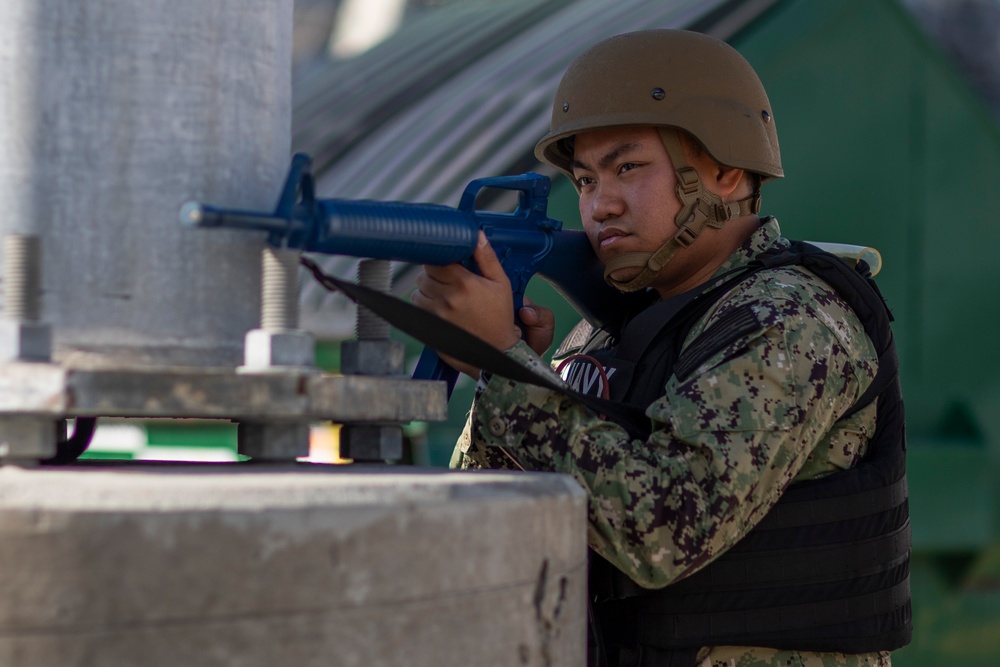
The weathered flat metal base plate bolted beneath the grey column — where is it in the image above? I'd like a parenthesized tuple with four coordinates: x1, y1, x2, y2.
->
(0, 362, 448, 423)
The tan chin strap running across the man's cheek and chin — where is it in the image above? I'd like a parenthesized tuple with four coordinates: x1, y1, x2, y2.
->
(604, 127, 760, 292)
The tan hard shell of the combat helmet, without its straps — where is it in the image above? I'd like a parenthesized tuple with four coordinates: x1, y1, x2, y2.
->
(535, 29, 784, 179)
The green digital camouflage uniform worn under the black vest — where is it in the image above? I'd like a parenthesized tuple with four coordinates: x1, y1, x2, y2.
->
(452, 219, 889, 667)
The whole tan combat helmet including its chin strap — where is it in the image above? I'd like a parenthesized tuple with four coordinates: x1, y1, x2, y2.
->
(535, 29, 784, 291)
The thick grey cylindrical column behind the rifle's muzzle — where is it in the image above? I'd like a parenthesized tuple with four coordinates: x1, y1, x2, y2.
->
(0, 0, 293, 367)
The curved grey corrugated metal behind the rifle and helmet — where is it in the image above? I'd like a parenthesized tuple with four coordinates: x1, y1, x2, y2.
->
(293, 0, 773, 335)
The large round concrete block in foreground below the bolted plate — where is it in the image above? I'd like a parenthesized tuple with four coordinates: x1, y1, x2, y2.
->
(0, 464, 587, 667)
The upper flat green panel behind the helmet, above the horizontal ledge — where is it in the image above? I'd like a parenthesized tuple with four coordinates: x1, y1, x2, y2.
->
(733, 0, 1000, 434)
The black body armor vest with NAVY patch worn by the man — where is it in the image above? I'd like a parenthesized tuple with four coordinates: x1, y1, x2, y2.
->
(561, 242, 911, 665)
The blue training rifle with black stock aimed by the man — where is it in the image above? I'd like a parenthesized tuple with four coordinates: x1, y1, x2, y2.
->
(180, 153, 623, 395)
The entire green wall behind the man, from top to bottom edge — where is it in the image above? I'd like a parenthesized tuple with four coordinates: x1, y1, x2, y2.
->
(734, 0, 1000, 667)
